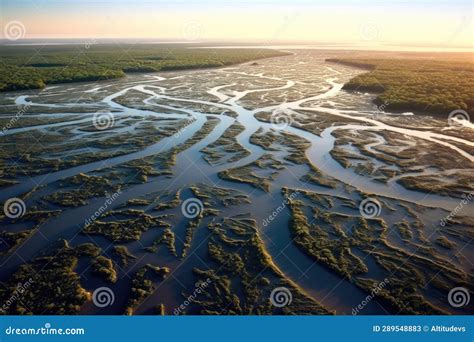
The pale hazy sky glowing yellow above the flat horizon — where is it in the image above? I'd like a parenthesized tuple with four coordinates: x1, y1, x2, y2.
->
(0, 0, 474, 49)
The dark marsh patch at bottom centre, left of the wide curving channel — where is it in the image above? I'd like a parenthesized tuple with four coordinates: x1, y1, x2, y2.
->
(183, 215, 330, 315)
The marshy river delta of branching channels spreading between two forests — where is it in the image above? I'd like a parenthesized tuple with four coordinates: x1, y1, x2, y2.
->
(0, 50, 474, 314)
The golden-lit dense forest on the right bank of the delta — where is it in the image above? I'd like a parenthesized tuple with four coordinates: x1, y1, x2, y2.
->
(327, 58, 474, 115)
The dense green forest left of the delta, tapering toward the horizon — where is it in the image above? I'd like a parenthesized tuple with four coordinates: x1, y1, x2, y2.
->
(0, 44, 285, 91)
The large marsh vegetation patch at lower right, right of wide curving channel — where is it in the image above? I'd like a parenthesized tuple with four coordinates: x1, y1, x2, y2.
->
(283, 189, 472, 314)
